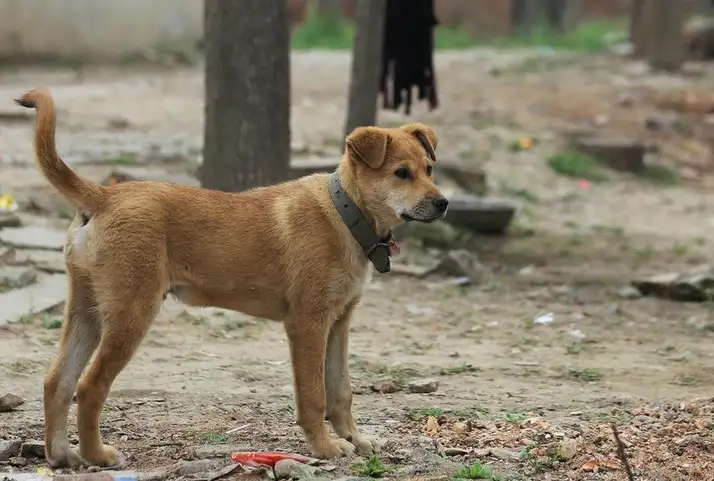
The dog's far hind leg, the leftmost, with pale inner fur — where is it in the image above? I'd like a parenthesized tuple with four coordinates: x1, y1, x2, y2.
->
(44, 265, 101, 467)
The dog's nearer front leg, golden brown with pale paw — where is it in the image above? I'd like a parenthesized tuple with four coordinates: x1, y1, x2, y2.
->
(285, 312, 355, 458)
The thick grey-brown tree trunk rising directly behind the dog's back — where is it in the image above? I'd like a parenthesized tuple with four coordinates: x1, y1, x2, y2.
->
(201, 0, 290, 192)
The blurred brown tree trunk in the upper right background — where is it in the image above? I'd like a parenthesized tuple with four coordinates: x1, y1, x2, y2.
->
(645, 0, 685, 72)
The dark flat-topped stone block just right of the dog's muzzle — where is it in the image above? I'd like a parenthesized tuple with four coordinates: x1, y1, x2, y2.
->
(444, 194, 516, 235)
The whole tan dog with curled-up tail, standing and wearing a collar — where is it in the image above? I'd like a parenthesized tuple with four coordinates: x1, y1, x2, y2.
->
(17, 90, 448, 466)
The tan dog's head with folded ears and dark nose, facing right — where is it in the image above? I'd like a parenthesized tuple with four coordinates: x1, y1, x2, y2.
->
(345, 123, 449, 227)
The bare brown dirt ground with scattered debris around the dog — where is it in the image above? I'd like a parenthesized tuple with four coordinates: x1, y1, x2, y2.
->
(0, 49, 714, 480)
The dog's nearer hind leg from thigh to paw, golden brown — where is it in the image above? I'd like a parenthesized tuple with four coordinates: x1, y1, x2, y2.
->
(77, 270, 164, 466)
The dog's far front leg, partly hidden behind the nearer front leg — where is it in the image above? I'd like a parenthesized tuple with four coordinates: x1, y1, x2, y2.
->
(325, 301, 379, 454)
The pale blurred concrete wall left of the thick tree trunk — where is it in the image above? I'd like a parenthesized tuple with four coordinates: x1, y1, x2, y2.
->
(0, 0, 203, 61)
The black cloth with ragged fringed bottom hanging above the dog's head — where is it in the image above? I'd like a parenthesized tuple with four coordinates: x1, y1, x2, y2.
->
(380, 0, 439, 115)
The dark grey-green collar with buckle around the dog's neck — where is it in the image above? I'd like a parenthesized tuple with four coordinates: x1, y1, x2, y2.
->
(329, 170, 396, 274)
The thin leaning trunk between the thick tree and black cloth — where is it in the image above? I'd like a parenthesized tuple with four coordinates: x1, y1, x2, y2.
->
(343, 0, 387, 144)
